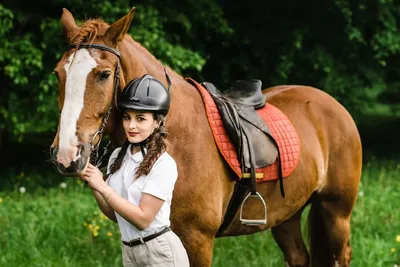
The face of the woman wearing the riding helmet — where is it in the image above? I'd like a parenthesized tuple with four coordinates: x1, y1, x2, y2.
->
(122, 110, 157, 146)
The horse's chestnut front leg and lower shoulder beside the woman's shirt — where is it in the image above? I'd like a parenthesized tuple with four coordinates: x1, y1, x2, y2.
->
(171, 152, 235, 267)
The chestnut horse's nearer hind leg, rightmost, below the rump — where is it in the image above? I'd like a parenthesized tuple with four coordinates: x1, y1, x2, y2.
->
(309, 165, 361, 267)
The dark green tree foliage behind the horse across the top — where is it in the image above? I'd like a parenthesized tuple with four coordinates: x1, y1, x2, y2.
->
(0, 0, 400, 139)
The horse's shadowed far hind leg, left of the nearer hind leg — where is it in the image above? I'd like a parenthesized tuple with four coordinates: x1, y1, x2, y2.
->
(272, 208, 310, 267)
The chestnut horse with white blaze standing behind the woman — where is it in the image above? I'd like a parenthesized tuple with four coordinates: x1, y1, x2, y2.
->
(51, 8, 362, 267)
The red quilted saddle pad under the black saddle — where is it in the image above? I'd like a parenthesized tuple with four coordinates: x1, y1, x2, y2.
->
(186, 78, 300, 182)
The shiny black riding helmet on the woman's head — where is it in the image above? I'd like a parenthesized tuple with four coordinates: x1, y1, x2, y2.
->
(118, 74, 171, 115)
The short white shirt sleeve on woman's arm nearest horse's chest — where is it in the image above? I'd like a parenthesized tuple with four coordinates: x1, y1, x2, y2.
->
(142, 155, 178, 201)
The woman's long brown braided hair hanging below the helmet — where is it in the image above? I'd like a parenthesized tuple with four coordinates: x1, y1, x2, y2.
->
(110, 113, 168, 179)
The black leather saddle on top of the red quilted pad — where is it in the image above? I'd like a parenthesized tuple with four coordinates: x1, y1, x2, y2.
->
(202, 80, 278, 172)
